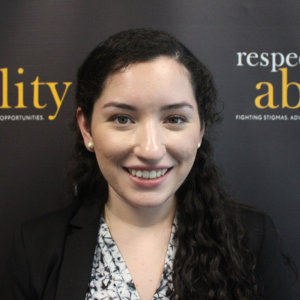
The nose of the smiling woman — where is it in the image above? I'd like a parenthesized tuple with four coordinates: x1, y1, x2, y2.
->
(134, 122, 166, 162)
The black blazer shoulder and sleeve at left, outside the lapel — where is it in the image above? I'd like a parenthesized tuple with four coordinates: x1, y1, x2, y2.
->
(0, 205, 79, 299)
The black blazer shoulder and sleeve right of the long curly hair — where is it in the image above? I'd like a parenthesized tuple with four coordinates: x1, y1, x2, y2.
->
(234, 205, 291, 299)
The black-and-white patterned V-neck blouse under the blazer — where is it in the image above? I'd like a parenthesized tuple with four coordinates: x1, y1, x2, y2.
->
(85, 218, 176, 300)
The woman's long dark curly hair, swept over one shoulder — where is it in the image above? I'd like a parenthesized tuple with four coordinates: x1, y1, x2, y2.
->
(72, 29, 259, 299)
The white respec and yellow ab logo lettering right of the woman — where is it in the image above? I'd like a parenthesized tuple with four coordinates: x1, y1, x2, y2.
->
(236, 52, 300, 121)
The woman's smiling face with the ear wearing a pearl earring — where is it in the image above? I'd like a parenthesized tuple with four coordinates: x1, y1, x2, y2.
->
(78, 57, 204, 211)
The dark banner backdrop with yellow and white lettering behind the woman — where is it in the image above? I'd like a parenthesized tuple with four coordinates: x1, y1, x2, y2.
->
(0, 0, 300, 299)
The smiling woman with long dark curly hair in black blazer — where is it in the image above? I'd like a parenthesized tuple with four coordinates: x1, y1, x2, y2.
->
(3, 29, 290, 300)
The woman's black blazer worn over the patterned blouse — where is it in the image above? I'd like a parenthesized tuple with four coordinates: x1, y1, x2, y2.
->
(0, 196, 291, 300)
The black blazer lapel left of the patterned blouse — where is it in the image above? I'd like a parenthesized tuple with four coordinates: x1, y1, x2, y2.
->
(55, 197, 100, 300)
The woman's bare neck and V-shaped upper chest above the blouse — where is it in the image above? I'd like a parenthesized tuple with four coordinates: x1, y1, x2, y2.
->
(105, 192, 175, 299)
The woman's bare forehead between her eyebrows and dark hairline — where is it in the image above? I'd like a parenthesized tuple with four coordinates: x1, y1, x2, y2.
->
(100, 57, 194, 107)
